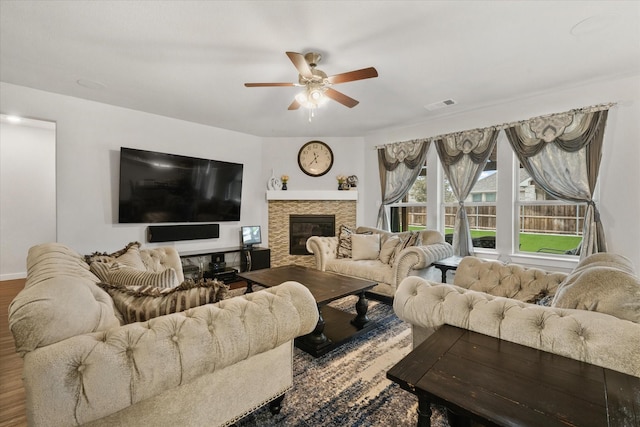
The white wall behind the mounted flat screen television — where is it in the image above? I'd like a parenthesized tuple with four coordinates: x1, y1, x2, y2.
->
(0, 83, 266, 268)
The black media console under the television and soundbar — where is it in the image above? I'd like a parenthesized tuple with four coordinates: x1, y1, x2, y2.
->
(180, 246, 271, 282)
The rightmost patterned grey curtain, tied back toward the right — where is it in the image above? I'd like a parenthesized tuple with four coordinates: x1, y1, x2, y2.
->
(505, 105, 610, 259)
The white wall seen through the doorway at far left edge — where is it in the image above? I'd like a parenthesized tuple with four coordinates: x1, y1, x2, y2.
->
(0, 120, 56, 280)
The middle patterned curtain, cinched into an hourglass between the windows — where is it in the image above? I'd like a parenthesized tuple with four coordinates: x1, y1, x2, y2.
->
(435, 128, 498, 256)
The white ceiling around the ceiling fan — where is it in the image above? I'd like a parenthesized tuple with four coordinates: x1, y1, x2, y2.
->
(0, 0, 640, 137)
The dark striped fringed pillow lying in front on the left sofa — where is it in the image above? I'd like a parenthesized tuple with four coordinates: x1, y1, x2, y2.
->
(98, 279, 229, 323)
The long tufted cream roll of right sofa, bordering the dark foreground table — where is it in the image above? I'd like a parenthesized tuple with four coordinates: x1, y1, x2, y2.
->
(393, 277, 640, 377)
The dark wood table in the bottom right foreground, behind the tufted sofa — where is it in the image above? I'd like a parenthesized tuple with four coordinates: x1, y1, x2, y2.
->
(387, 325, 640, 427)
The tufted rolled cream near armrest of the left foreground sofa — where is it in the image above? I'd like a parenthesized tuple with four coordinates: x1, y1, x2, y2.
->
(24, 282, 318, 425)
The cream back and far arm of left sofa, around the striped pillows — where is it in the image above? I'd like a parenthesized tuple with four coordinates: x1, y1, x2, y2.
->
(9, 243, 184, 355)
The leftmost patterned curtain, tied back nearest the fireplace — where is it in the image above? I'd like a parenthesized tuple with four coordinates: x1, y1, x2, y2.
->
(377, 139, 430, 230)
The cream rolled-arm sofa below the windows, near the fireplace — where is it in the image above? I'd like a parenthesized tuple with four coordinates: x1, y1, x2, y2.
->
(307, 227, 453, 298)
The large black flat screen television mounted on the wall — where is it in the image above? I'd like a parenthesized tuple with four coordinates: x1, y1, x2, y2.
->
(118, 147, 243, 223)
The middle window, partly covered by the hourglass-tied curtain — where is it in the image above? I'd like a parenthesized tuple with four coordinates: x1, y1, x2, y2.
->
(443, 144, 498, 249)
